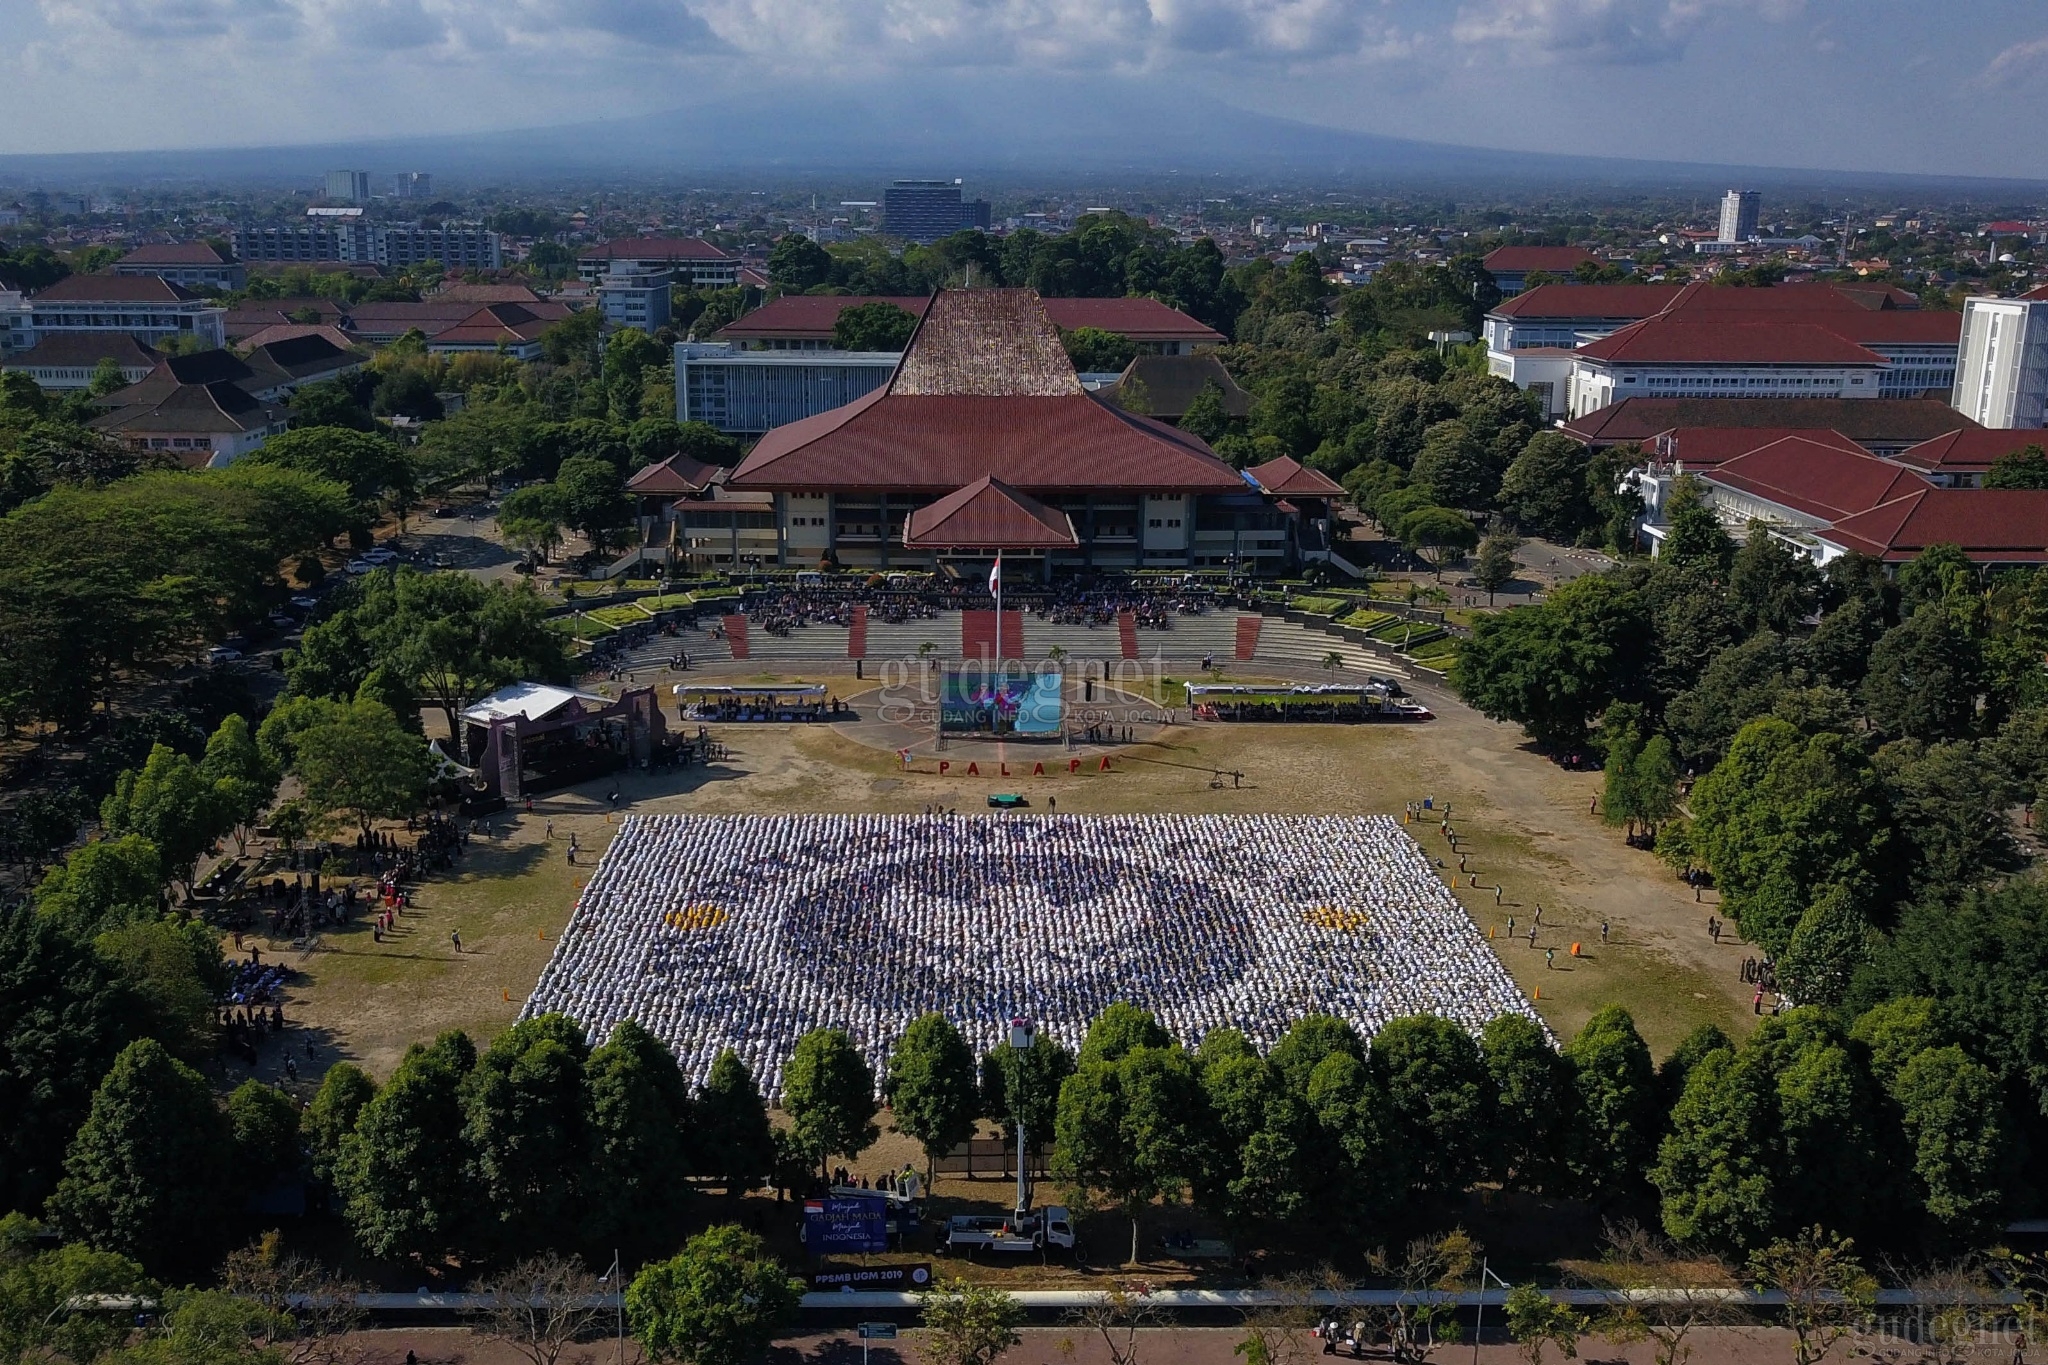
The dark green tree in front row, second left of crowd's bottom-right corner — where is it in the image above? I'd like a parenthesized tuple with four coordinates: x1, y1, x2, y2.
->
(1372, 1015, 1499, 1203)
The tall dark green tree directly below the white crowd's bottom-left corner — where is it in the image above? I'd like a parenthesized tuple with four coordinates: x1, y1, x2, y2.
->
(463, 1015, 590, 1254)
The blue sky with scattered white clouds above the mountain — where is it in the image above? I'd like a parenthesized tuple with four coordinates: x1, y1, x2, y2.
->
(12, 0, 2048, 178)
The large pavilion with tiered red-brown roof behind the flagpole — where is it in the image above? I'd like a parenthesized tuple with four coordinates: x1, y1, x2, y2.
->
(712, 289, 1300, 579)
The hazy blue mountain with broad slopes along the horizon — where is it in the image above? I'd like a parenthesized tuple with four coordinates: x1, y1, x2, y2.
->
(0, 76, 2040, 194)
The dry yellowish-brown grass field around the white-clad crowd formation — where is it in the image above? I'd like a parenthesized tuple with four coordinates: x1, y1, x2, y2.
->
(268, 673, 1749, 1074)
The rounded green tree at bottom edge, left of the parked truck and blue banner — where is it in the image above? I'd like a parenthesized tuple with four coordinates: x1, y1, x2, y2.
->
(627, 1224, 803, 1365)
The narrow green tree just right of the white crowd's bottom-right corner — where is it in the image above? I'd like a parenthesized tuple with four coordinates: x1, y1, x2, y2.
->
(1565, 1005, 1663, 1203)
